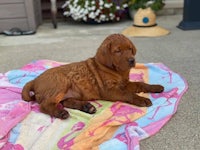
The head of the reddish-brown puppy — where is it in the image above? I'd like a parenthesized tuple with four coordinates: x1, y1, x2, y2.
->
(95, 34, 136, 71)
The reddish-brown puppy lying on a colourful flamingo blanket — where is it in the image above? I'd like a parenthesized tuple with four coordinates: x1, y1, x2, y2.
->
(22, 34, 164, 119)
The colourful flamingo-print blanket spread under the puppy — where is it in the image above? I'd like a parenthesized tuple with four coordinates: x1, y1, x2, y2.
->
(0, 60, 188, 150)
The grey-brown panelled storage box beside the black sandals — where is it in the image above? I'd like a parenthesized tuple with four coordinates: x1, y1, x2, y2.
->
(0, 0, 42, 32)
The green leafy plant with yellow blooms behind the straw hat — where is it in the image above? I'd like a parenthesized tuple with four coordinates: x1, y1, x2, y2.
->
(128, 0, 165, 17)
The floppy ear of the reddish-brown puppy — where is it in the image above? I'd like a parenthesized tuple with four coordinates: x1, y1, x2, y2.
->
(95, 40, 112, 68)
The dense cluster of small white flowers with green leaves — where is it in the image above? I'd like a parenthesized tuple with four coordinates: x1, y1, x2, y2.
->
(62, 0, 128, 23)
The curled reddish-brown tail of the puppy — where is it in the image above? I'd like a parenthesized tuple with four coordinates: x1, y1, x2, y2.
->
(22, 80, 35, 101)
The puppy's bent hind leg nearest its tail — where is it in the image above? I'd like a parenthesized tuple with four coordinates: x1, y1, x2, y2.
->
(40, 94, 69, 119)
